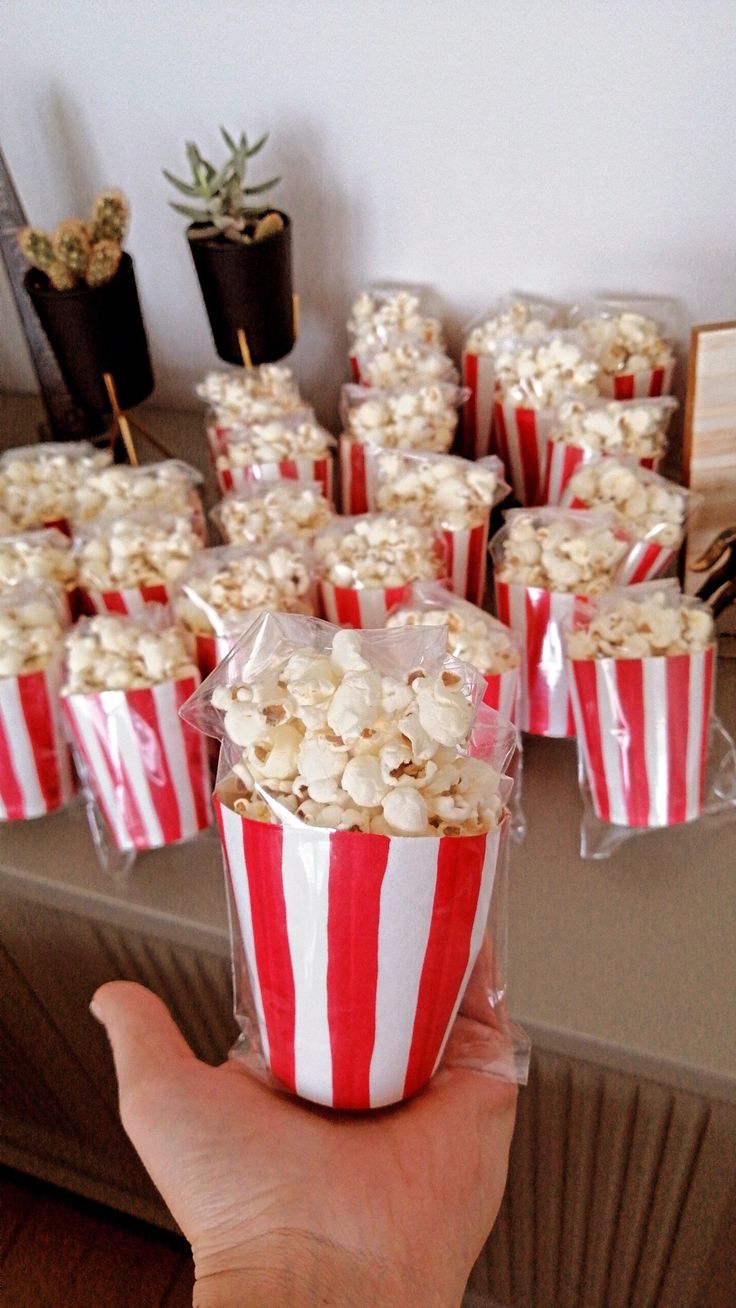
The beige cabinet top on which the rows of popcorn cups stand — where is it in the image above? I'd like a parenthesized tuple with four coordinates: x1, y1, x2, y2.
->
(0, 402, 736, 1097)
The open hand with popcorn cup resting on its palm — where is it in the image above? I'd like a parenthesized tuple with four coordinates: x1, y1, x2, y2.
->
(92, 981, 516, 1308)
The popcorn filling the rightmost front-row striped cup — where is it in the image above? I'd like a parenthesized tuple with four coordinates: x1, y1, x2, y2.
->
(567, 590, 714, 659)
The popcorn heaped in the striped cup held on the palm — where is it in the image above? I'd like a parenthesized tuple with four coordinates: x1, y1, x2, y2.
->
(212, 630, 503, 836)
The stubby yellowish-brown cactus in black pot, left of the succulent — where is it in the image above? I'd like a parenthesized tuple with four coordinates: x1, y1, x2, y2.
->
(18, 187, 153, 416)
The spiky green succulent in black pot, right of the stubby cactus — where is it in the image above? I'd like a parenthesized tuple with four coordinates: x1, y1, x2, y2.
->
(163, 127, 295, 364)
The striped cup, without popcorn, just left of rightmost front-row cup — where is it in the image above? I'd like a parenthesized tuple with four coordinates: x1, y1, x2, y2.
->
(495, 579, 586, 736)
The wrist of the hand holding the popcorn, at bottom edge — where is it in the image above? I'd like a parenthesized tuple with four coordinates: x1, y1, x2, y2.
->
(193, 1231, 459, 1308)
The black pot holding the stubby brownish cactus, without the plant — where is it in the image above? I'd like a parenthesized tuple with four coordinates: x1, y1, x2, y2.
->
(24, 254, 153, 413)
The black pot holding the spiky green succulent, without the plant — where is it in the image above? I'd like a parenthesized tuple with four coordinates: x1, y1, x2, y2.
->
(190, 211, 295, 364)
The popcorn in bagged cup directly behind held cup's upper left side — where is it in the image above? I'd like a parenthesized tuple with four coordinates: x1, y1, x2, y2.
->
(174, 544, 314, 636)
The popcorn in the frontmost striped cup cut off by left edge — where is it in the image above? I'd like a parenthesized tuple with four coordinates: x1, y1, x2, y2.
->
(0, 585, 64, 676)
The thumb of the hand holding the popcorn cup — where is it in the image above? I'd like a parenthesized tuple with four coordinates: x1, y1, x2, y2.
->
(90, 981, 196, 1100)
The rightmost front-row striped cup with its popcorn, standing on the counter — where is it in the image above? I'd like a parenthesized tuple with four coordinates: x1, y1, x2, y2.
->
(565, 591, 733, 828)
